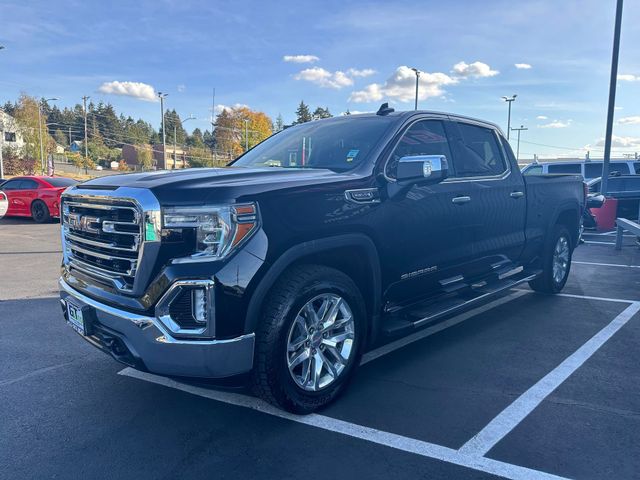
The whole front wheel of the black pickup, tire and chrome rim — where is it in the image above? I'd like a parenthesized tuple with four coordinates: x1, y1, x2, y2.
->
(253, 265, 366, 414)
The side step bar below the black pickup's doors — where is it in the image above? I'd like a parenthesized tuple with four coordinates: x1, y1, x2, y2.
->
(383, 270, 541, 335)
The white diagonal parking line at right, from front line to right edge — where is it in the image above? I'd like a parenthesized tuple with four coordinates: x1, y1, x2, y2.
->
(460, 302, 640, 457)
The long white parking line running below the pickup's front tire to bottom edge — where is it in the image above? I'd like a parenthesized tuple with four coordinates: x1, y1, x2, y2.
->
(118, 367, 563, 480)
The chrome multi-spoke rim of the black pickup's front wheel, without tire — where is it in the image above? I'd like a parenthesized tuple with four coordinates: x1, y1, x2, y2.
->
(287, 293, 355, 392)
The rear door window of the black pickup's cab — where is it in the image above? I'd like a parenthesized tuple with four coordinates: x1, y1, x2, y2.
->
(455, 123, 507, 177)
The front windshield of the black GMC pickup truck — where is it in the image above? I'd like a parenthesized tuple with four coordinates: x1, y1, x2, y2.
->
(233, 116, 393, 172)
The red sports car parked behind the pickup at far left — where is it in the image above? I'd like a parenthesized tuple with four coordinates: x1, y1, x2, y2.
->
(0, 175, 78, 223)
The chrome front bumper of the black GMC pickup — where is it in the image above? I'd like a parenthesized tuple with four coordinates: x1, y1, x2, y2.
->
(59, 279, 255, 378)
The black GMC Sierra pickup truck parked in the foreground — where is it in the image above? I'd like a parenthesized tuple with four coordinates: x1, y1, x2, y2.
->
(60, 105, 585, 413)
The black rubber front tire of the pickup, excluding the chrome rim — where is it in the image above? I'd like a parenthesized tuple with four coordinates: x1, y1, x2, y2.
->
(252, 265, 367, 414)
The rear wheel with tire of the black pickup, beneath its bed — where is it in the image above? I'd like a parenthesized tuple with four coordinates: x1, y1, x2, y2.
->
(529, 225, 573, 293)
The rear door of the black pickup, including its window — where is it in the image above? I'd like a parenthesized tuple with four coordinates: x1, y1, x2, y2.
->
(447, 121, 526, 275)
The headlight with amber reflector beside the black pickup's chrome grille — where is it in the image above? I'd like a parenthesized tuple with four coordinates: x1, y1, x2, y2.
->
(163, 203, 258, 260)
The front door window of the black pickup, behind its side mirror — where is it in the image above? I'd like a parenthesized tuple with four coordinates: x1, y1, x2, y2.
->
(386, 120, 451, 178)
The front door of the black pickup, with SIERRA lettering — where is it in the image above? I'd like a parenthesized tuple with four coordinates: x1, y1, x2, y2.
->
(379, 119, 472, 304)
